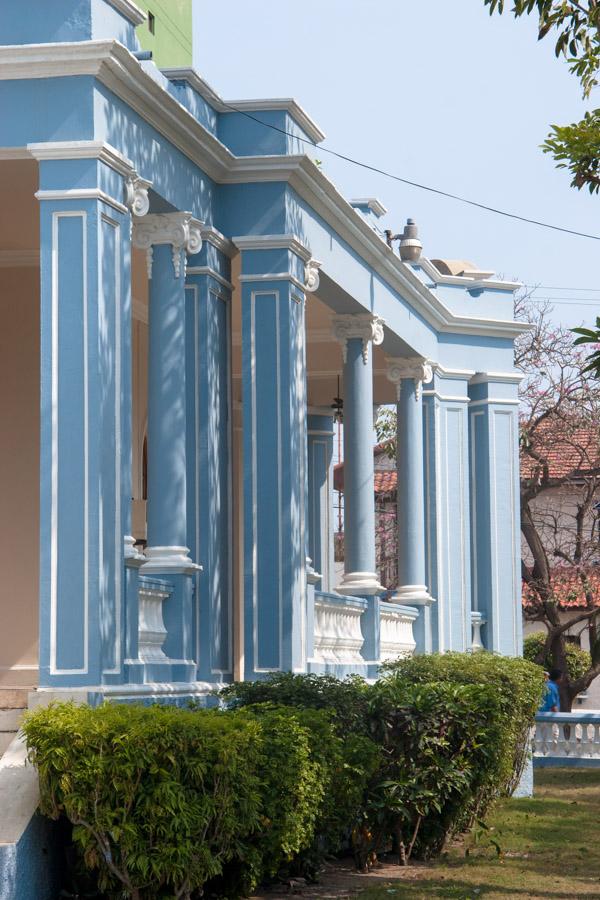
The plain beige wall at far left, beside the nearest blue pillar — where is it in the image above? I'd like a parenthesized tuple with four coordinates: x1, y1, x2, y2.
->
(0, 268, 40, 685)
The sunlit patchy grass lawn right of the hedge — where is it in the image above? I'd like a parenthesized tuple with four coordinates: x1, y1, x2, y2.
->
(360, 769, 600, 900)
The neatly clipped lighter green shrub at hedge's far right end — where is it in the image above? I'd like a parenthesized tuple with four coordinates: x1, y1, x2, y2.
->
(383, 652, 544, 800)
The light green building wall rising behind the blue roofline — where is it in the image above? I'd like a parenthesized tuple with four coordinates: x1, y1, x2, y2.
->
(135, 0, 192, 69)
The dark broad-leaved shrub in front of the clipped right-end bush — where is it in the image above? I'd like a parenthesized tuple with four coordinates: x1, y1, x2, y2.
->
(355, 674, 503, 868)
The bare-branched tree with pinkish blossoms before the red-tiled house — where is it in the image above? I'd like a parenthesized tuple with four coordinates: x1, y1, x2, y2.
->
(515, 295, 600, 710)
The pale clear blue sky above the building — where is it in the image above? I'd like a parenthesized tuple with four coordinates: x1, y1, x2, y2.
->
(193, 0, 600, 325)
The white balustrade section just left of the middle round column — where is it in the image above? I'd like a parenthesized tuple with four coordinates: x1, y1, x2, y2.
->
(314, 593, 367, 666)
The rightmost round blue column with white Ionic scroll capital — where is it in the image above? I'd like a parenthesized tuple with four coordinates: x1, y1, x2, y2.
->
(387, 358, 433, 653)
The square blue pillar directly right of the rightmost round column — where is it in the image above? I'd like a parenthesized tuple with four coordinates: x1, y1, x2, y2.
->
(423, 366, 472, 652)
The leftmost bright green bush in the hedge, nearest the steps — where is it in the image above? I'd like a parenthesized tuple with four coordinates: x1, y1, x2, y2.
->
(23, 704, 263, 898)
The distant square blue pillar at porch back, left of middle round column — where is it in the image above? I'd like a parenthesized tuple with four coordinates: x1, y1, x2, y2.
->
(307, 415, 334, 591)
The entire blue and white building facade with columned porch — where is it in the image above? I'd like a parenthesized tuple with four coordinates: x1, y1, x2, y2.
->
(0, 0, 521, 702)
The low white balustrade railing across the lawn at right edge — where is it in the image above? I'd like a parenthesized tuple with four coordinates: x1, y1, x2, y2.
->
(533, 711, 600, 767)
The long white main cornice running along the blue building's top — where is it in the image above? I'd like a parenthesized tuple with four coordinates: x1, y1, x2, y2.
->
(0, 40, 526, 339)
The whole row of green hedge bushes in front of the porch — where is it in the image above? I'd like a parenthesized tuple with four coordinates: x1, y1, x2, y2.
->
(24, 653, 543, 900)
